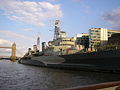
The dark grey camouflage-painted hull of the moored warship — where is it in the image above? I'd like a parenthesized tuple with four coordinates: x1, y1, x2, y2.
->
(19, 50, 120, 73)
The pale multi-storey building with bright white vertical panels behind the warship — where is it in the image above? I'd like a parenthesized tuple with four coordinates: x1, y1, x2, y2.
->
(89, 28, 120, 48)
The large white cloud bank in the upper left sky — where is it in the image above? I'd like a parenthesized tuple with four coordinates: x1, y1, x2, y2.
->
(0, 0, 63, 26)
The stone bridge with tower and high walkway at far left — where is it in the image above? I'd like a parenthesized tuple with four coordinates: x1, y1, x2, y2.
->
(0, 43, 16, 62)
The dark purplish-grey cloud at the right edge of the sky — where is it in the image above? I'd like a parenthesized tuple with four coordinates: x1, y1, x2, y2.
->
(103, 7, 120, 29)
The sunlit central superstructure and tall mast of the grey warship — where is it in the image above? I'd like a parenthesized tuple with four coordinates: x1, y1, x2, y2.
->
(43, 20, 77, 55)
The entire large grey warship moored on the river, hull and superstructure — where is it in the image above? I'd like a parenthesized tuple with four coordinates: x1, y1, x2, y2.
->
(19, 20, 120, 73)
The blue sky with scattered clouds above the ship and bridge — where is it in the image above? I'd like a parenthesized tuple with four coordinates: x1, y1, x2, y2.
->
(0, 0, 120, 56)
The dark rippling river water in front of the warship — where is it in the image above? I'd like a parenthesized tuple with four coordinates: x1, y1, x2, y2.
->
(0, 60, 120, 90)
